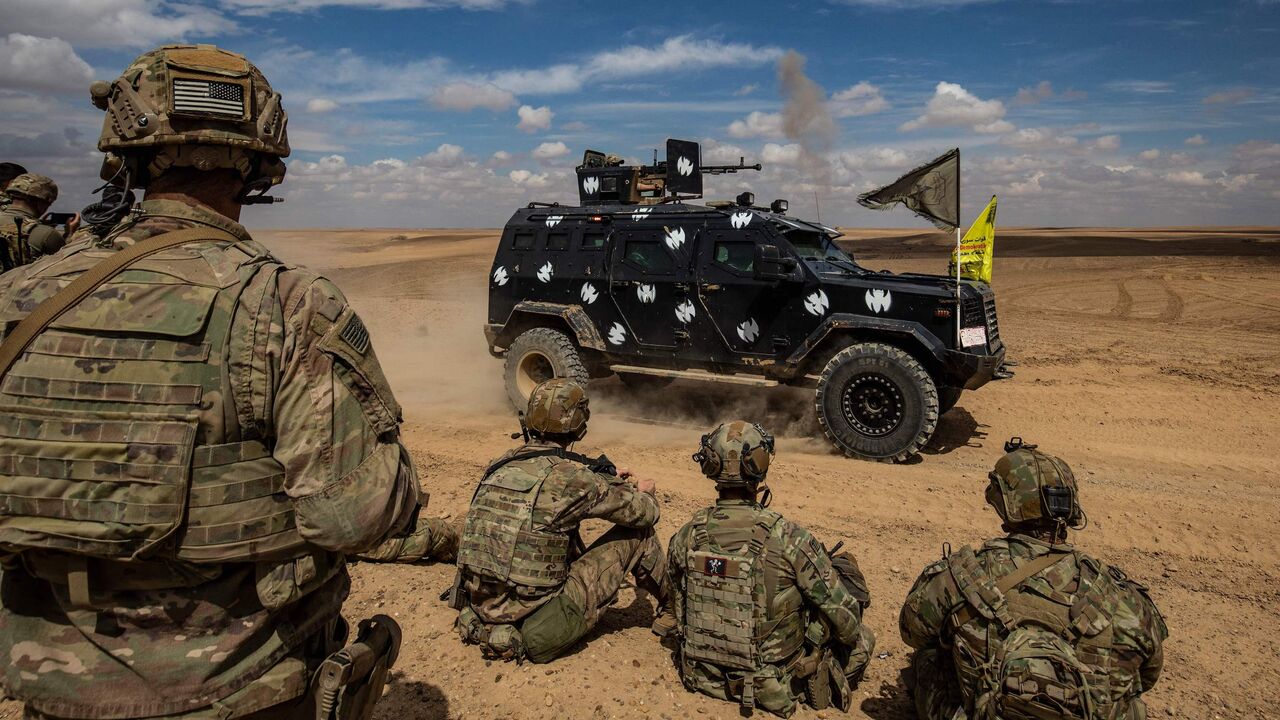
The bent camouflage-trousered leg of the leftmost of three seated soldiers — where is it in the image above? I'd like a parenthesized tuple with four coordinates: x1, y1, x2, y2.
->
(520, 525, 667, 662)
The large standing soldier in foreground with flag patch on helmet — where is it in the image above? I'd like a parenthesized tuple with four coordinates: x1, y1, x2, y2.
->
(0, 45, 417, 720)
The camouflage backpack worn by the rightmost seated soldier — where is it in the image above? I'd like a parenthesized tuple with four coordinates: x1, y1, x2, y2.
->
(950, 547, 1111, 720)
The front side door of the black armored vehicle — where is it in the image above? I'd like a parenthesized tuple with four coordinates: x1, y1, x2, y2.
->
(698, 215, 801, 356)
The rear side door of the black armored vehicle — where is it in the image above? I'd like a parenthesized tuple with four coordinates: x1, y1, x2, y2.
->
(605, 224, 692, 350)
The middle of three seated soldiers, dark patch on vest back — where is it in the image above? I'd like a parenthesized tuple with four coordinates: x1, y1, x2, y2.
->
(655, 420, 876, 717)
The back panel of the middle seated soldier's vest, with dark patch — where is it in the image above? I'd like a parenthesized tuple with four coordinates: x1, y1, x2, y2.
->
(681, 510, 782, 708)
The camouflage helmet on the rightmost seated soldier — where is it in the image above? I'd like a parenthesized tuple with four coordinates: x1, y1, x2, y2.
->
(987, 437, 1084, 529)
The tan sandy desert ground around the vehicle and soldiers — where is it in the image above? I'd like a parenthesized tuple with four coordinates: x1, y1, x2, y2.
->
(0, 228, 1280, 720)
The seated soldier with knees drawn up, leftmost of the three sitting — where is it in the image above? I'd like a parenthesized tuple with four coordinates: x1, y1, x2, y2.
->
(453, 378, 667, 662)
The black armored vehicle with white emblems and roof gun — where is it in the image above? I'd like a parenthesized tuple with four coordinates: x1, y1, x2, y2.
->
(485, 140, 1005, 461)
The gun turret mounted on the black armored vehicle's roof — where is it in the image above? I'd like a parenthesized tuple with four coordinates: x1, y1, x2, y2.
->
(577, 140, 762, 205)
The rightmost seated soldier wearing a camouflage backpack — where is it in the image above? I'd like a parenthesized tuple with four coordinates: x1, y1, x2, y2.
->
(899, 438, 1169, 720)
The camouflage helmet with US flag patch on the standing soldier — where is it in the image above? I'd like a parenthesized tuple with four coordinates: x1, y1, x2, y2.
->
(90, 45, 289, 188)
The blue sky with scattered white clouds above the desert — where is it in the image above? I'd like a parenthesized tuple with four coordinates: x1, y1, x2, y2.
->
(0, 0, 1280, 228)
